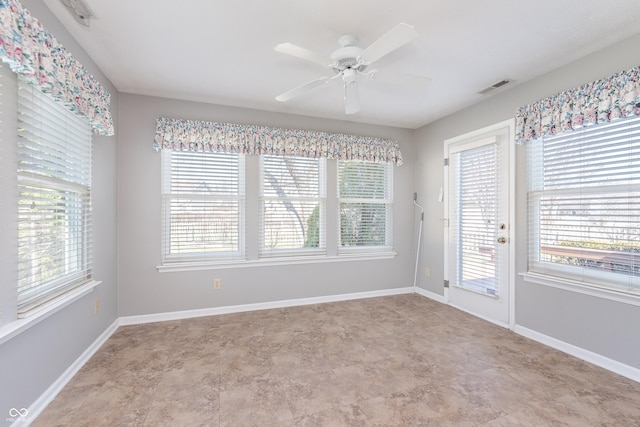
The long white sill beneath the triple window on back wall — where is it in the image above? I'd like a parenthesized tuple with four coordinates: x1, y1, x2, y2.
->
(156, 251, 397, 273)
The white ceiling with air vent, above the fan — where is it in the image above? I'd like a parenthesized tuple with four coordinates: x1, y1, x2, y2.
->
(45, 0, 640, 129)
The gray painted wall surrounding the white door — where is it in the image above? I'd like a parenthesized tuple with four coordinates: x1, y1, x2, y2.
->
(415, 36, 640, 368)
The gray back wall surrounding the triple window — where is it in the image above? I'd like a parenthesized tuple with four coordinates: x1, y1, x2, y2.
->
(118, 94, 415, 316)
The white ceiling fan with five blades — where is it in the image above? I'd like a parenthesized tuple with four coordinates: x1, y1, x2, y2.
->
(274, 23, 431, 114)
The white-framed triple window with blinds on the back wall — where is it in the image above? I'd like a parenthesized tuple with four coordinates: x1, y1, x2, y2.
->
(158, 153, 395, 271)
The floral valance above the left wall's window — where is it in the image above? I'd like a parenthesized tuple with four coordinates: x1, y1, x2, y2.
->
(0, 0, 113, 135)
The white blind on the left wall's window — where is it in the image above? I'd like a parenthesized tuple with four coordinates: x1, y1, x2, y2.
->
(17, 80, 92, 317)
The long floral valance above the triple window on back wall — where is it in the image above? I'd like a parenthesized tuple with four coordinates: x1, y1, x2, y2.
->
(153, 118, 402, 166)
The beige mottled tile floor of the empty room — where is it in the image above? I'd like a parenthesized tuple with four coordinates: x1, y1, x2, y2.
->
(33, 295, 640, 427)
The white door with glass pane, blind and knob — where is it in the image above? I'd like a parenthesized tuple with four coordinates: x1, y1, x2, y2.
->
(444, 120, 514, 327)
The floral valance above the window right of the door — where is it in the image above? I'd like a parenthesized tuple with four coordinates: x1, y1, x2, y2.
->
(516, 67, 640, 144)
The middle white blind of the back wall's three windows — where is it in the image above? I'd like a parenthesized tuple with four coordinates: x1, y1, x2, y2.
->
(260, 155, 326, 256)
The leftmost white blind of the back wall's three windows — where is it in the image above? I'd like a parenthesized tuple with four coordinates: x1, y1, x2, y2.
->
(162, 150, 245, 263)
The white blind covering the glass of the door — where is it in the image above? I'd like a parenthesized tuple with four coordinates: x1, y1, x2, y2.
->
(449, 143, 502, 295)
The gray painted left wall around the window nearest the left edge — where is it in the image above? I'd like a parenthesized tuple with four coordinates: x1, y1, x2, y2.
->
(0, 0, 118, 425)
